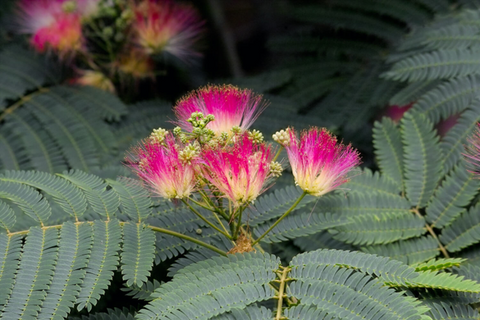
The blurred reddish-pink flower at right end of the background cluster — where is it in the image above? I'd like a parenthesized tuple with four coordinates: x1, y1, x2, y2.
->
(132, 0, 203, 60)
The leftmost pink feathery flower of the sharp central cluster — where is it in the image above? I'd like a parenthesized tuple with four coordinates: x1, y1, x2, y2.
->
(126, 133, 198, 199)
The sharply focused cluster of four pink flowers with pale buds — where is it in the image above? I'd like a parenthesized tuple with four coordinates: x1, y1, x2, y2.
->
(127, 85, 360, 208)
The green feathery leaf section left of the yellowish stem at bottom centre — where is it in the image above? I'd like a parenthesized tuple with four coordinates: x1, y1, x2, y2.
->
(138, 253, 279, 320)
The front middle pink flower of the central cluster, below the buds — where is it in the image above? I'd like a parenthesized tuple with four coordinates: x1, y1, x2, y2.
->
(201, 134, 273, 207)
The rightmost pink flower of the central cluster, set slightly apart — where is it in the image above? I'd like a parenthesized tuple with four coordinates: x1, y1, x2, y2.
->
(285, 128, 360, 197)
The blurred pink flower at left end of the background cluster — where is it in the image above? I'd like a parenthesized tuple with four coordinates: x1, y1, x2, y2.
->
(18, 0, 84, 57)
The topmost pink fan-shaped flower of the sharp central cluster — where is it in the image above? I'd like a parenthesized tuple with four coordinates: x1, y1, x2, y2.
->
(174, 85, 266, 135)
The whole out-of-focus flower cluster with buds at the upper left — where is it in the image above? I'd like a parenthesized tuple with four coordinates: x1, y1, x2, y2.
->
(17, 0, 203, 91)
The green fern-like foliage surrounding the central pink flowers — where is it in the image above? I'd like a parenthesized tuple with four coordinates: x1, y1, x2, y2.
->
(0, 0, 480, 320)
